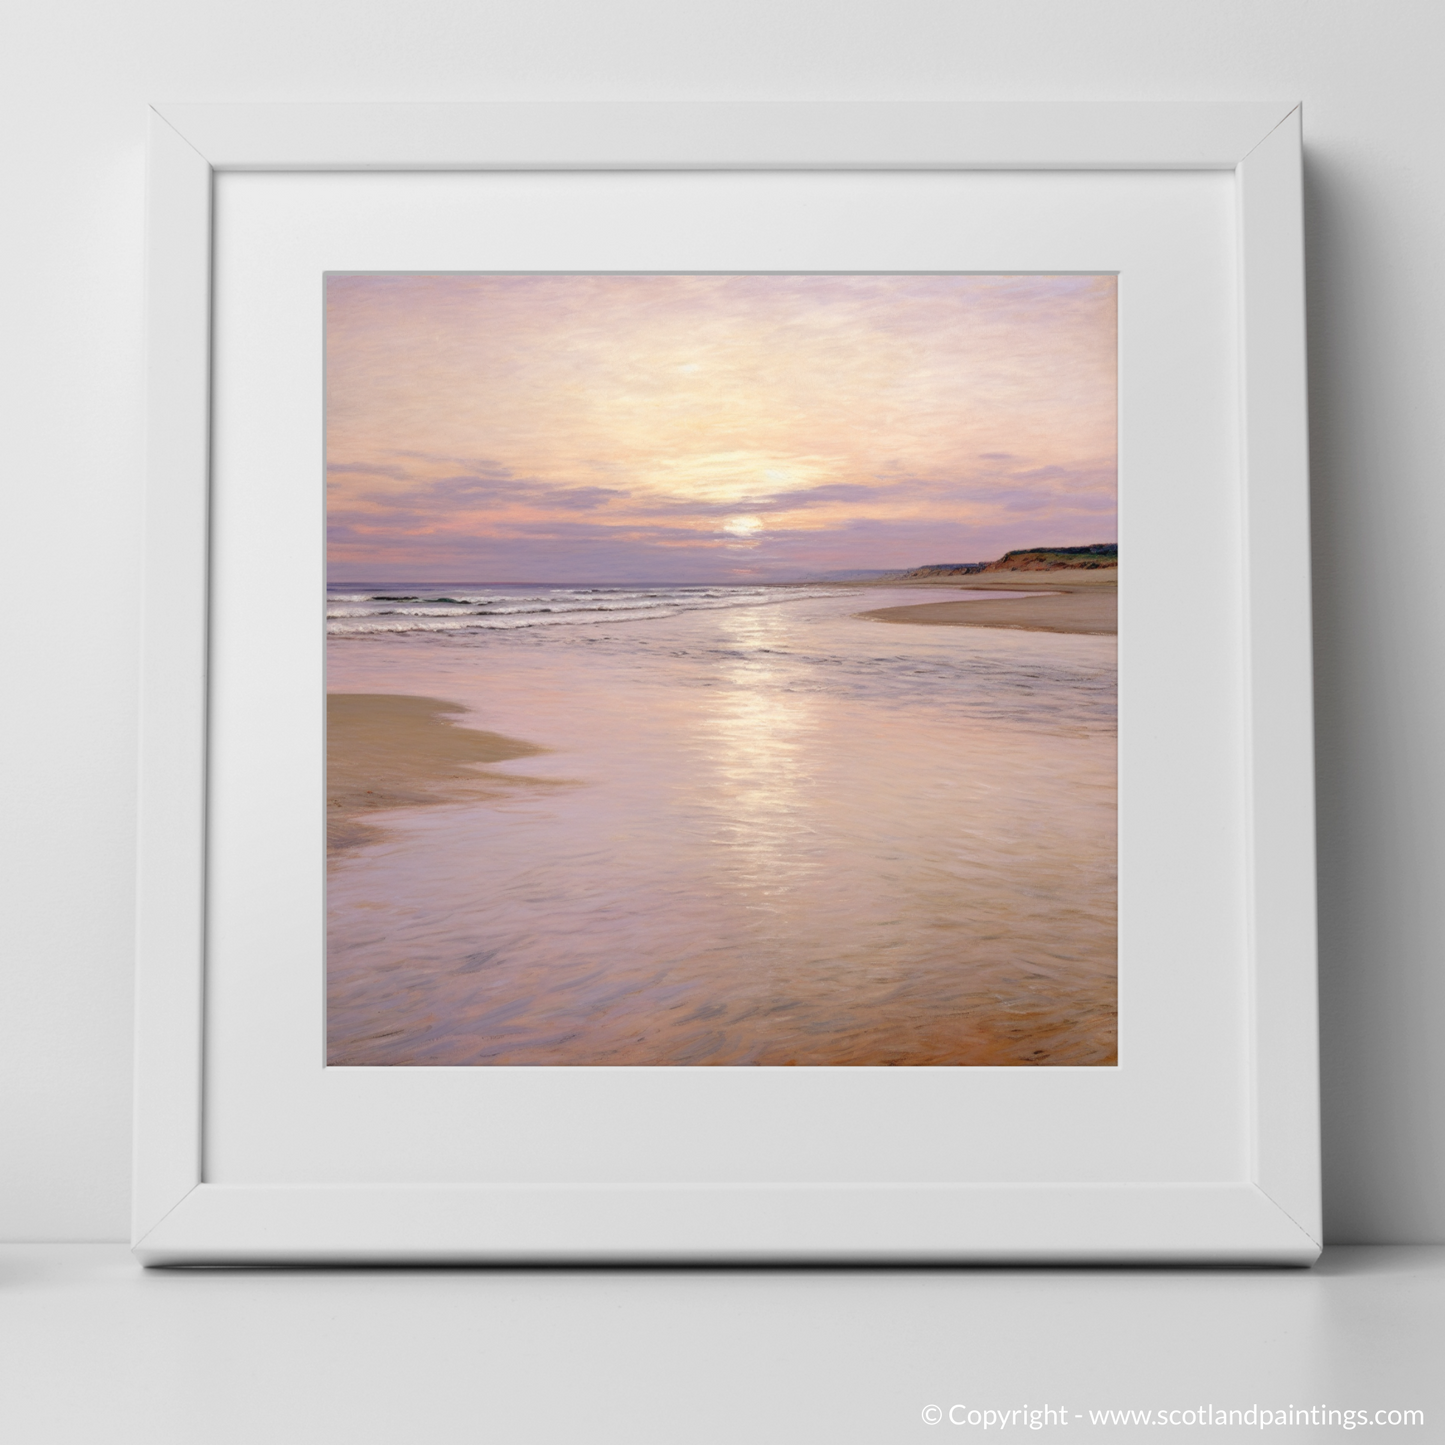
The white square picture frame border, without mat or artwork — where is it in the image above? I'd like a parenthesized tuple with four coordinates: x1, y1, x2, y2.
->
(133, 103, 1321, 1264)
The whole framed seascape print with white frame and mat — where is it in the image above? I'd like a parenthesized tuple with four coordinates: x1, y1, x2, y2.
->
(134, 104, 1319, 1264)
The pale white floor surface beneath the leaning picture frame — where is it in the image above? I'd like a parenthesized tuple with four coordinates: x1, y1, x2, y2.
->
(0, 1244, 1445, 1445)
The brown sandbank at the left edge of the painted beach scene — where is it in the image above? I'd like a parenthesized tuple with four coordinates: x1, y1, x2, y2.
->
(327, 692, 548, 855)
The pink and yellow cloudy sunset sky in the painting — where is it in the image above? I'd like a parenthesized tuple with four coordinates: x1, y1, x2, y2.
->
(327, 275, 1116, 582)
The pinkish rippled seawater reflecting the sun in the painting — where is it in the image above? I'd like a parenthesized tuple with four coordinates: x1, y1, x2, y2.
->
(327, 582, 1117, 1066)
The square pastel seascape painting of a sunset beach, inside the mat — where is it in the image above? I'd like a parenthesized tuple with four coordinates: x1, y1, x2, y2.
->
(327, 273, 1118, 1066)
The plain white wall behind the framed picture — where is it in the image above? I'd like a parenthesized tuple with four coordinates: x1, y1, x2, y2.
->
(0, 0, 1445, 1241)
